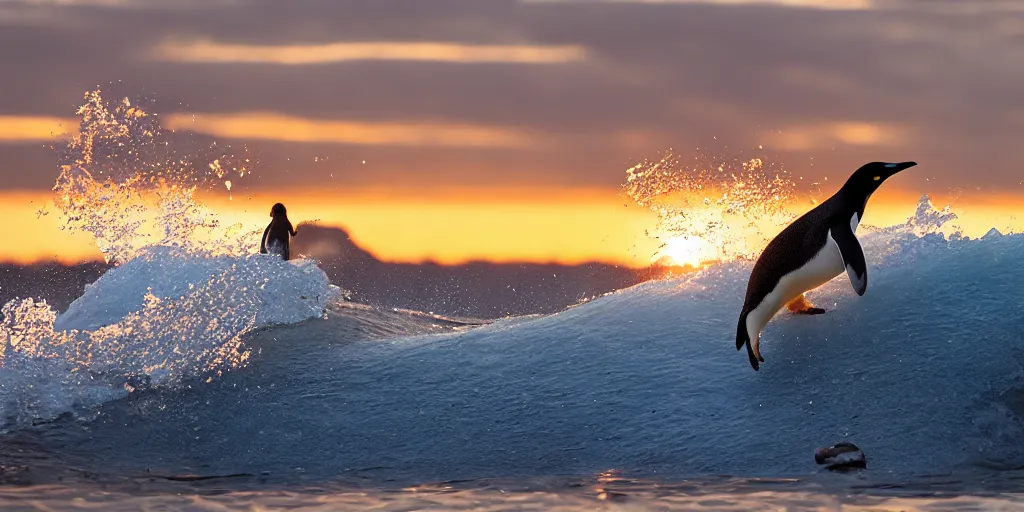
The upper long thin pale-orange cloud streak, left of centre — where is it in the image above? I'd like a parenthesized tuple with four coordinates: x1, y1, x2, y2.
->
(153, 39, 587, 66)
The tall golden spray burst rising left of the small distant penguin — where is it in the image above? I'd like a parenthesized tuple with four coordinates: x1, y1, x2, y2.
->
(53, 90, 259, 263)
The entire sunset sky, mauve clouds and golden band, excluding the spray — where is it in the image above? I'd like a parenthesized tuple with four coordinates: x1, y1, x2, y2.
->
(0, 0, 1024, 265)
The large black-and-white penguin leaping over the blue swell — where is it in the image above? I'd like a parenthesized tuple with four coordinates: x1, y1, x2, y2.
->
(736, 162, 918, 370)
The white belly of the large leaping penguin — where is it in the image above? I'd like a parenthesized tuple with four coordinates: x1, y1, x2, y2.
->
(746, 236, 846, 341)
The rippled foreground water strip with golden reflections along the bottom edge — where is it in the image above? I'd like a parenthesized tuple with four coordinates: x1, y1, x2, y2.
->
(0, 468, 1024, 512)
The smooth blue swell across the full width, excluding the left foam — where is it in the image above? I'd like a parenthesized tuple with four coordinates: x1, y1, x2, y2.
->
(0, 209, 1024, 509)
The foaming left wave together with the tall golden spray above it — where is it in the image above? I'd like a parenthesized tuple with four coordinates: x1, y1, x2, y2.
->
(0, 90, 341, 427)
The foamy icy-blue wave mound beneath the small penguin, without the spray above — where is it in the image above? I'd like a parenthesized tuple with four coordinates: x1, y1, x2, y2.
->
(0, 247, 342, 428)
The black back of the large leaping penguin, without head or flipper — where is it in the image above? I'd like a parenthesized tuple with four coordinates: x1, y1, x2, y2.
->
(740, 195, 857, 311)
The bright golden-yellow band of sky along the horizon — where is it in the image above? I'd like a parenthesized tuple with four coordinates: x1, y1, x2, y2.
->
(0, 188, 1024, 267)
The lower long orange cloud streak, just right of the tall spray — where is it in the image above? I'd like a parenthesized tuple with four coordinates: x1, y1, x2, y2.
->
(163, 112, 538, 148)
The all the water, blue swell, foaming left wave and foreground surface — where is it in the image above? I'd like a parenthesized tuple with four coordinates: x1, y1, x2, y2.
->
(0, 91, 1024, 510)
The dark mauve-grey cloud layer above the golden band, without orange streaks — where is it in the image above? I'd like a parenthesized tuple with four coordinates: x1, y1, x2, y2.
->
(0, 0, 1024, 191)
